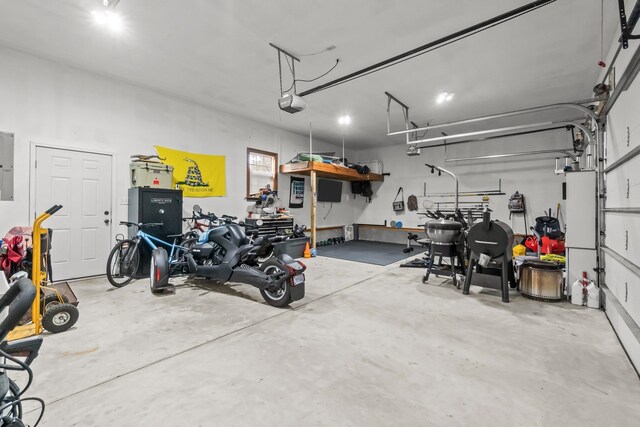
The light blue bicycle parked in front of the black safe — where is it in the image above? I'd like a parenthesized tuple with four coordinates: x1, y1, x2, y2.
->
(107, 221, 197, 288)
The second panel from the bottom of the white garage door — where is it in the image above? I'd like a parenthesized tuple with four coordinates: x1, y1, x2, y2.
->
(604, 253, 640, 323)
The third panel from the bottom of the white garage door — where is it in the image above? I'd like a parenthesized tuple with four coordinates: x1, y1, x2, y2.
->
(605, 212, 640, 261)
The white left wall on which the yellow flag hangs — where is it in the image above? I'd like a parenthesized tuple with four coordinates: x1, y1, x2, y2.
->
(0, 47, 353, 236)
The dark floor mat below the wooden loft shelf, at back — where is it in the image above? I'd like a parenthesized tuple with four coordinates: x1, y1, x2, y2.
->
(317, 240, 425, 265)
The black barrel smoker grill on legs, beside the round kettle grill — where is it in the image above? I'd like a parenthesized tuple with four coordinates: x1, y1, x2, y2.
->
(462, 210, 513, 302)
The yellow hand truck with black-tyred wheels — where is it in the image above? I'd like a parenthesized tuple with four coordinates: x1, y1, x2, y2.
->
(7, 205, 80, 341)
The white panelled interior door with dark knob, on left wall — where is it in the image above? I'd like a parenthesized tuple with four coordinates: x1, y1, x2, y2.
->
(33, 147, 112, 280)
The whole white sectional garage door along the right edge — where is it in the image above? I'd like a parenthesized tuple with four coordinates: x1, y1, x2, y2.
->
(604, 51, 640, 366)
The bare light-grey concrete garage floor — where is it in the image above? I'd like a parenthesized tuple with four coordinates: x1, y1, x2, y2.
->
(22, 257, 640, 427)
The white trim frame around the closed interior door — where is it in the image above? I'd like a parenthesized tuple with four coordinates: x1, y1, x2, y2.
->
(27, 141, 118, 247)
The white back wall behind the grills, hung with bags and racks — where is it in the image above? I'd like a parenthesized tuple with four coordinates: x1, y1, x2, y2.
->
(356, 131, 571, 233)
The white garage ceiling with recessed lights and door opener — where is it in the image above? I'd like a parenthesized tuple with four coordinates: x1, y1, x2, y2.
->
(0, 0, 617, 148)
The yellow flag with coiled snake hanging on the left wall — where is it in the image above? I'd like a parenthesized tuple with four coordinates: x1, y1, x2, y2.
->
(155, 145, 227, 197)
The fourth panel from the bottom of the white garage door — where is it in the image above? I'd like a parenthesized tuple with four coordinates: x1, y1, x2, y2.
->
(606, 156, 640, 208)
